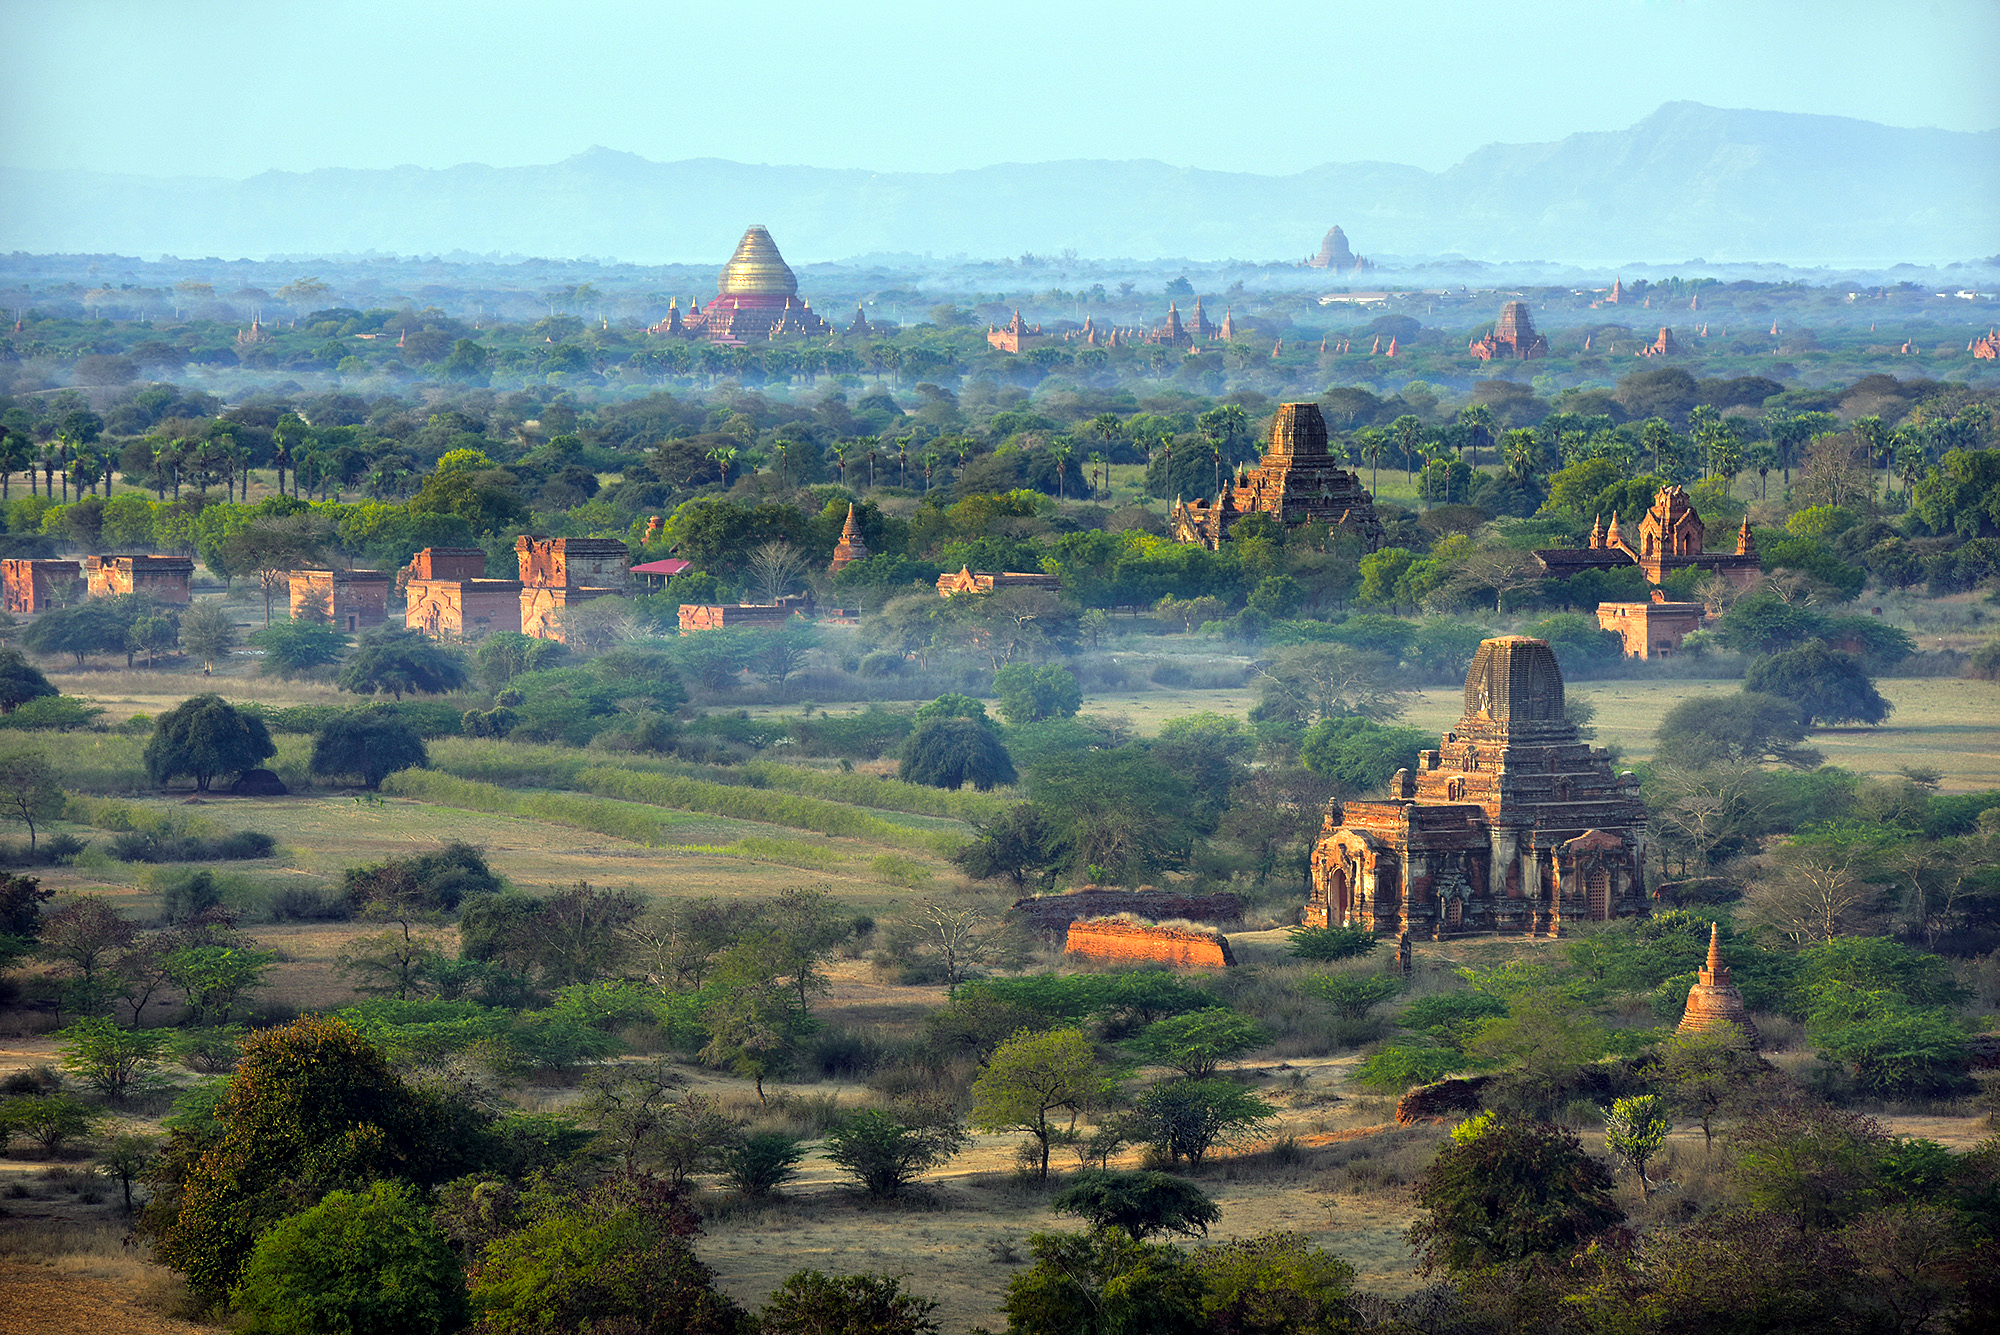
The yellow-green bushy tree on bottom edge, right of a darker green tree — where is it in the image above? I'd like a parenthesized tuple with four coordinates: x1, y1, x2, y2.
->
(1194, 1231, 1358, 1335)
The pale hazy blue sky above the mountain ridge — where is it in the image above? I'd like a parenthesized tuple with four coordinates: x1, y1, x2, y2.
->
(0, 0, 2000, 176)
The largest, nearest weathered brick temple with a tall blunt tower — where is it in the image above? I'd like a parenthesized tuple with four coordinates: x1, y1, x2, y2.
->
(1304, 636, 1648, 939)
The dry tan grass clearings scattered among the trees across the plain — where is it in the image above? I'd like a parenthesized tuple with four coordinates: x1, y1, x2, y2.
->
(0, 656, 2000, 1335)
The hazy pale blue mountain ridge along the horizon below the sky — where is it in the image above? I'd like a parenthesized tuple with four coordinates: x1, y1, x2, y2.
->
(0, 102, 2000, 264)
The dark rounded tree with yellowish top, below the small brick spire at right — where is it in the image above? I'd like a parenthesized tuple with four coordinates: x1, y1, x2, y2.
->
(1410, 1113, 1624, 1273)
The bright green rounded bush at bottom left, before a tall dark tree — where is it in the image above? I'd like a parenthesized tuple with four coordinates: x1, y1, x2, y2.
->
(232, 1181, 470, 1335)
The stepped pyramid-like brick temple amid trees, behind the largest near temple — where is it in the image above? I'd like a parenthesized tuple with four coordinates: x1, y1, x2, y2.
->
(1168, 404, 1382, 552)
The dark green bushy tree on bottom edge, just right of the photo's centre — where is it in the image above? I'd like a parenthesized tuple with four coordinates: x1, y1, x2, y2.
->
(1000, 1229, 1212, 1335)
